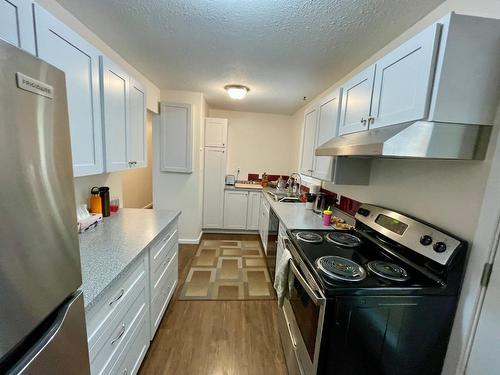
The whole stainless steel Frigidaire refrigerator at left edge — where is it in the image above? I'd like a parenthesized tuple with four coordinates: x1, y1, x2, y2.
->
(0, 40, 90, 375)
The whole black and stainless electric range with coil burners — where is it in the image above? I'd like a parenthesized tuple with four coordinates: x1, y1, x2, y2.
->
(280, 204, 468, 375)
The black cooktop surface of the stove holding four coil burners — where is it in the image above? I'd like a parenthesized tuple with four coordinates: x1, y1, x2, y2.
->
(289, 223, 467, 297)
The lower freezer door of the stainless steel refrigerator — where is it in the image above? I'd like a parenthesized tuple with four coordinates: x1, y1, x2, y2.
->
(7, 292, 90, 375)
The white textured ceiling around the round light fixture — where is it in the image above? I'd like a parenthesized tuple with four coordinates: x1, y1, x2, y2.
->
(57, 0, 443, 114)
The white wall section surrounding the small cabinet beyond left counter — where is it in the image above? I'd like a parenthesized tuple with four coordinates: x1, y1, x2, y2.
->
(153, 90, 207, 242)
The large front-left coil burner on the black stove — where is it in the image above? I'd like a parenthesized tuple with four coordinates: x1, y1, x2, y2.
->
(316, 255, 366, 282)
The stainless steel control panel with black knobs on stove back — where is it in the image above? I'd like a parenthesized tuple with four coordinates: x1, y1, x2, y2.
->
(355, 204, 461, 265)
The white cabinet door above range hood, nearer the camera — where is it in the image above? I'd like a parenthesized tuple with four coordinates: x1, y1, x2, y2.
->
(370, 24, 440, 128)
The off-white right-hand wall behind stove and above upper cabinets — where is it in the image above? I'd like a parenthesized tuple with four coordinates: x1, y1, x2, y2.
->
(293, 0, 500, 375)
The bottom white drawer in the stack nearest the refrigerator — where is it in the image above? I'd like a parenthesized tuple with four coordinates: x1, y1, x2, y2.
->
(110, 315, 149, 375)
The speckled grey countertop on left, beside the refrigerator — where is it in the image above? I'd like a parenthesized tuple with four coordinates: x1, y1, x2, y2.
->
(79, 208, 181, 310)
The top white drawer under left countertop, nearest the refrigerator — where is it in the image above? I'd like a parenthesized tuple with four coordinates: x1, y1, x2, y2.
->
(86, 256, 147, 352)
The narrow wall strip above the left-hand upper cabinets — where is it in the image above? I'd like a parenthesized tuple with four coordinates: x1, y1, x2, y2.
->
(35, 0, 160, 113)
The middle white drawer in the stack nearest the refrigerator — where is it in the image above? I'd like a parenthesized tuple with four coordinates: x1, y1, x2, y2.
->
(90, 286, 148, 374)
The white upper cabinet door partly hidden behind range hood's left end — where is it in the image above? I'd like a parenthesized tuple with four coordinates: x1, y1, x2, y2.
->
(312, 89, 341, 181)
